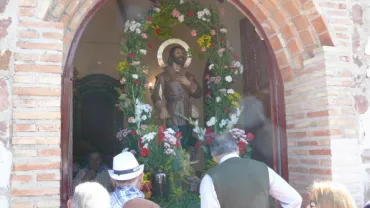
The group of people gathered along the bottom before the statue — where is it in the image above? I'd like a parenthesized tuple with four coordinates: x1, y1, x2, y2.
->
(68, 133, 370, 208)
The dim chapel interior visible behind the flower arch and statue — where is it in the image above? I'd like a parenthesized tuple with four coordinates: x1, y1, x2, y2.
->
(73, 0, 272, 171)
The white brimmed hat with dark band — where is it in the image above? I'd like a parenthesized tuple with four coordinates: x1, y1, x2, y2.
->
(108, 152, 144, 181)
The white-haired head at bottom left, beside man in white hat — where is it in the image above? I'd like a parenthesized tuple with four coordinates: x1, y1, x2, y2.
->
(67, 182, 110, 208)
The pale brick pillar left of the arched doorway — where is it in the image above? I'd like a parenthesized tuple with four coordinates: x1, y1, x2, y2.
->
(11, 1, 64, 208)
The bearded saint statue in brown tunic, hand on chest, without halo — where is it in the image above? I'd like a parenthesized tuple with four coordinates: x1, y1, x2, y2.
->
(152, 46, 202, 149)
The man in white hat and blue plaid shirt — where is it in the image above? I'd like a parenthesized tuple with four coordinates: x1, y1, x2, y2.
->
(108, 152, 159, 208)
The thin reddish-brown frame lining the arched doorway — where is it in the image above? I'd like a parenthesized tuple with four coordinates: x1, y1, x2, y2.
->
(60, 0, 288, 207)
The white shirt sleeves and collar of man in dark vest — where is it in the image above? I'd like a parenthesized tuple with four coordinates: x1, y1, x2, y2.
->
(200, 153, 302, 208)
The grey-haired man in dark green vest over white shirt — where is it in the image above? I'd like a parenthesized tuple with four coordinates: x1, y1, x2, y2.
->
(200, 133, 302, 208)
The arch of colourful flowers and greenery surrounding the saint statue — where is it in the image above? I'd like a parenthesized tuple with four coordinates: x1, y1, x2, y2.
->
(117, 0, 250, 205)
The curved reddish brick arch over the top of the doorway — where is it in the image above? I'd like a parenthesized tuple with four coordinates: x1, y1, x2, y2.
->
(45, 0, 333, 81)
